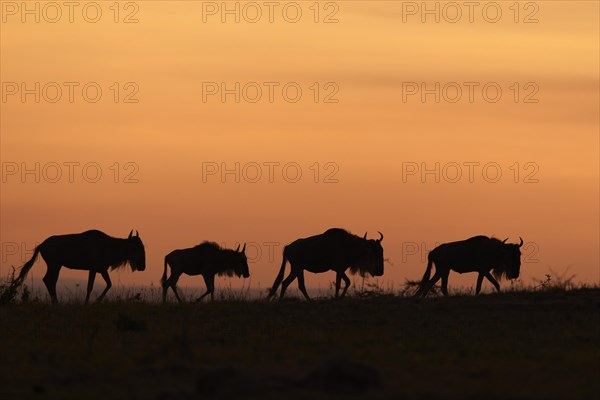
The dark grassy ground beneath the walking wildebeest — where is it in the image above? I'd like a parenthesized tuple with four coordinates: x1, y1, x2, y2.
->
(0, 289, 600, 400)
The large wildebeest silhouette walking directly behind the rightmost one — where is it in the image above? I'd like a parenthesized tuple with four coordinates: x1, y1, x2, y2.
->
(268, 228, 383, 300)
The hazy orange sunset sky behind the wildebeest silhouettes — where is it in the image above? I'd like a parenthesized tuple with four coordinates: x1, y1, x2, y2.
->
(0, 1, 600, 289)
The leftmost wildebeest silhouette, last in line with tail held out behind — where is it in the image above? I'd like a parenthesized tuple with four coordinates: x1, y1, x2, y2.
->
(17, 230, 146, 303)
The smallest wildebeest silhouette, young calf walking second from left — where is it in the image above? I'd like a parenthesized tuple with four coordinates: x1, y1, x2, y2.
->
(160, 242, 250, 303)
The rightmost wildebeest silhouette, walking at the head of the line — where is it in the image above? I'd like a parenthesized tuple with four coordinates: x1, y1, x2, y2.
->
(416, 236, 523, 296)
